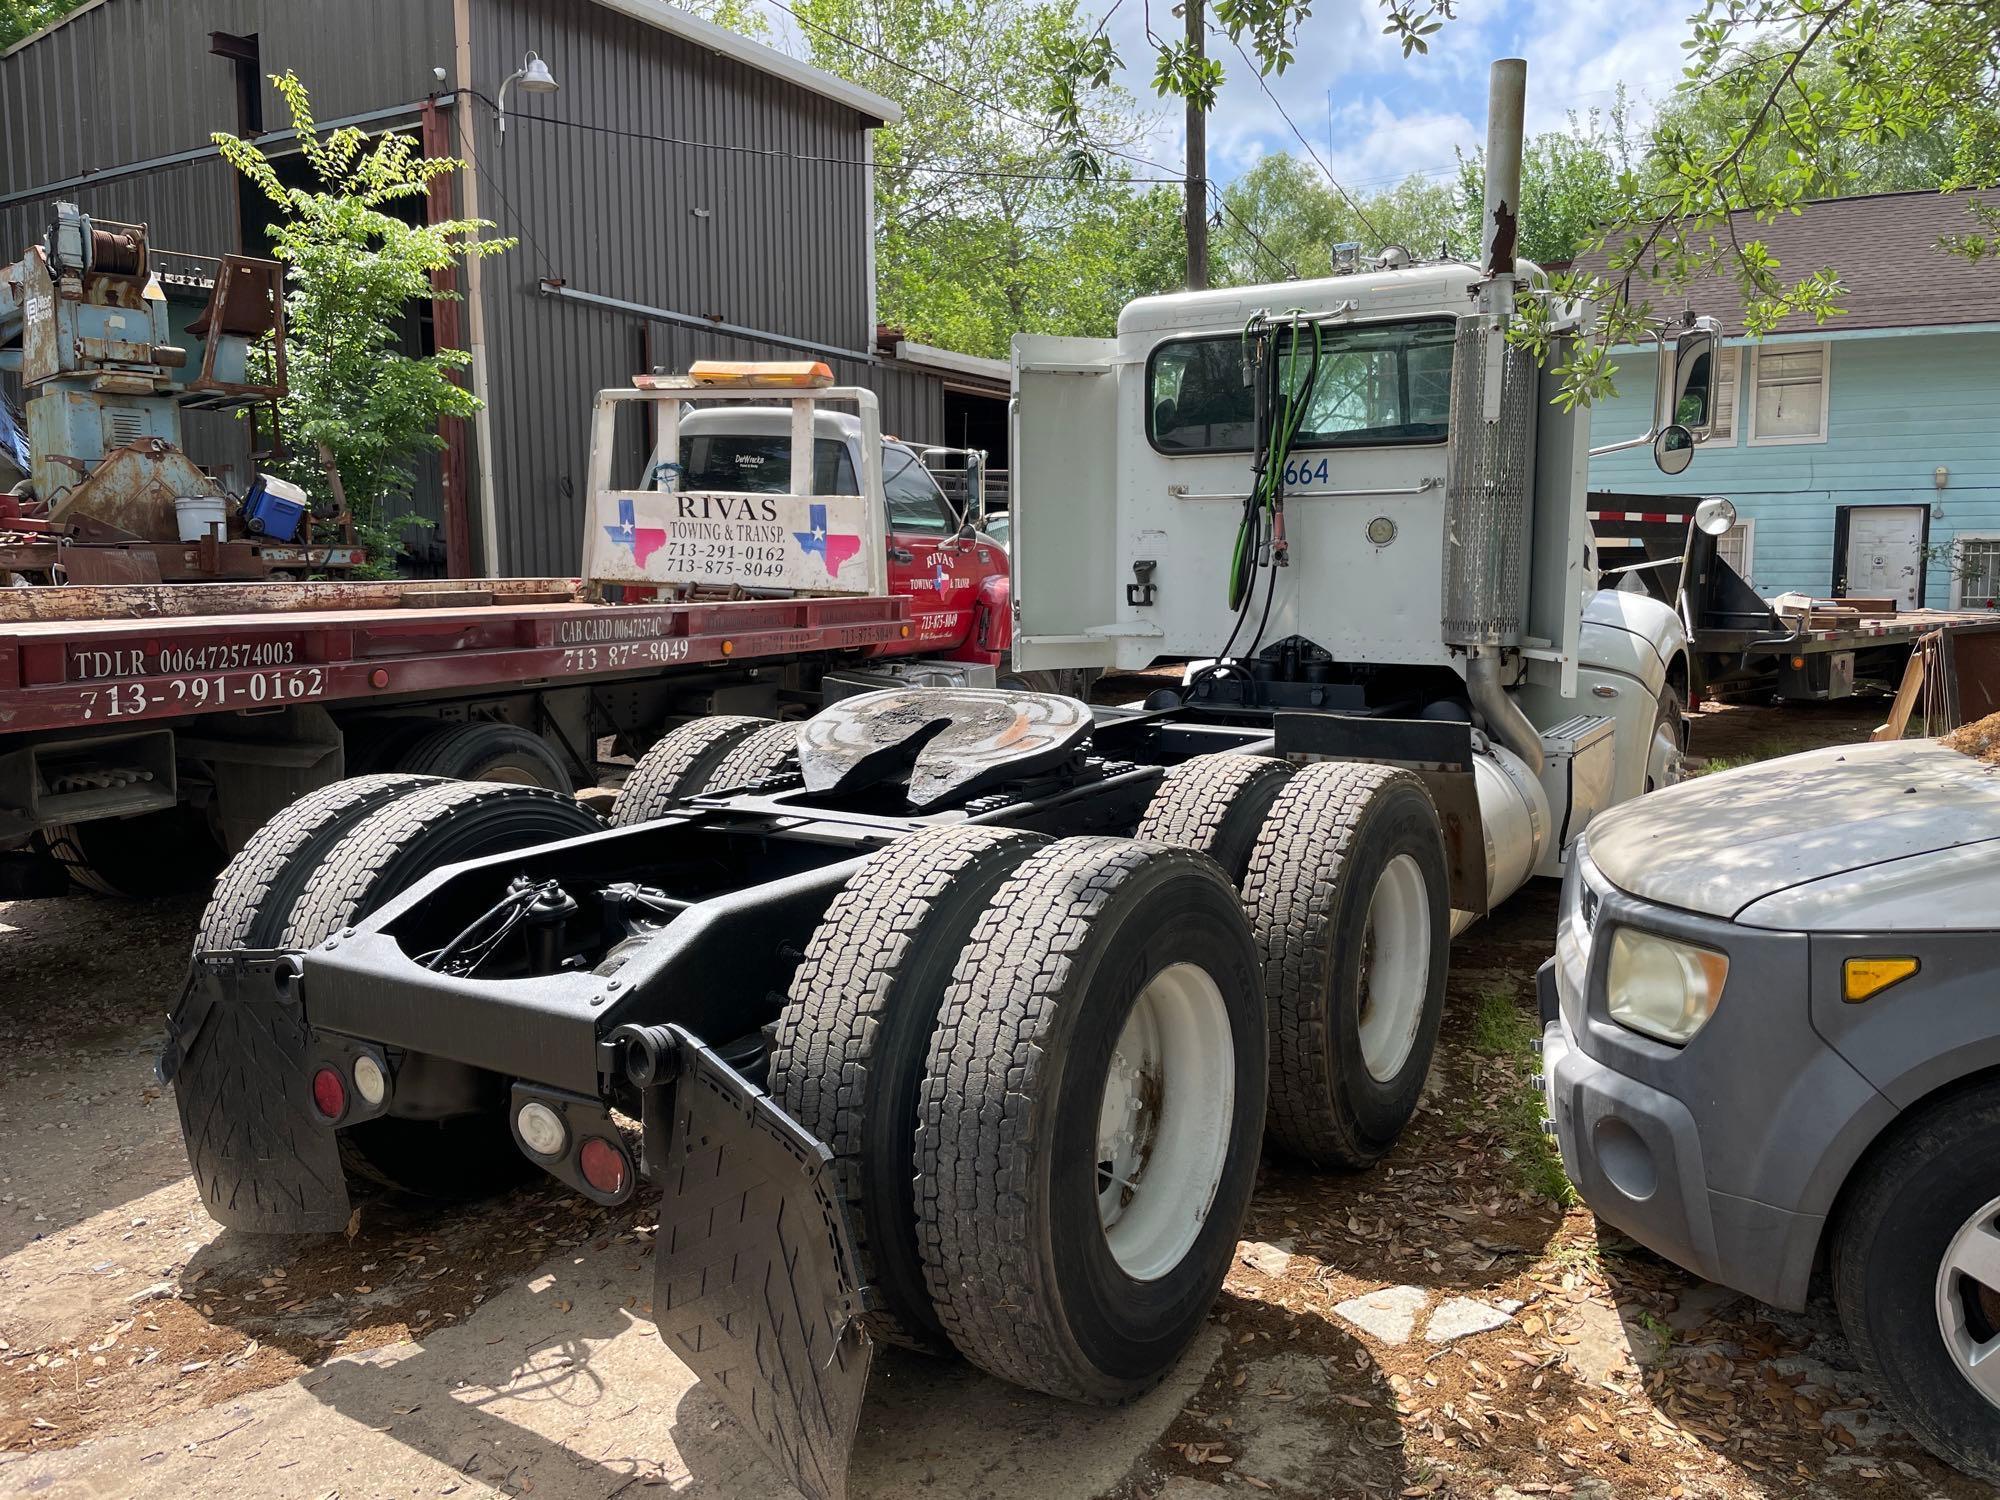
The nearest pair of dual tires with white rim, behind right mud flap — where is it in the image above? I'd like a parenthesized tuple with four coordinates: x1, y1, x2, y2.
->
(770, 826, 1264, 1402)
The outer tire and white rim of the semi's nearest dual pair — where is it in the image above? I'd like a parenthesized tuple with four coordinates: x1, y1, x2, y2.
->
(916, 838, 1264, 1402)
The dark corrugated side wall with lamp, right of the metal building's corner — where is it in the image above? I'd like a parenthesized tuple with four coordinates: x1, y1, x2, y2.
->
(468, 0, 892, 574)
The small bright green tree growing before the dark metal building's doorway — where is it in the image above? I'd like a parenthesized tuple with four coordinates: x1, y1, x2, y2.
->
(212, 72, 514, 566)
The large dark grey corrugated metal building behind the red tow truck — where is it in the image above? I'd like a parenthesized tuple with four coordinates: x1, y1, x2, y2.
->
(0, 0, 1006, 574)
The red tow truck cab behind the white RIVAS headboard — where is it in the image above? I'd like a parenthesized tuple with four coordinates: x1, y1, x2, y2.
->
(680, 406, 1010, 666)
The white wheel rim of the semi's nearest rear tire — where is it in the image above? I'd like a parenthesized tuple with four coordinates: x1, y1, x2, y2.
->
(1096, 964, 1236, 1282)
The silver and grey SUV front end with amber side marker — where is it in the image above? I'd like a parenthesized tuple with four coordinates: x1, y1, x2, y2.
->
(1538, 740, 2000, 1480)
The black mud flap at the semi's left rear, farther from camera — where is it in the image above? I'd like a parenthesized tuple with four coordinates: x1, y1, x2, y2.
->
(160, 952, 348, 1234)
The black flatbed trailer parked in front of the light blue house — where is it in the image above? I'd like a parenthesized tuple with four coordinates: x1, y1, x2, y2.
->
(1590, 494, 1996, 702)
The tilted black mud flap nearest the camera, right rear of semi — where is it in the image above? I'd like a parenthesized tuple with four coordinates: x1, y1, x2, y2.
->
(644, 1026, 874, 1500)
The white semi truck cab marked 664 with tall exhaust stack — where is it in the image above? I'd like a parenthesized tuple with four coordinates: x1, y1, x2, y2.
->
(1012, 60, 1716, 942)
